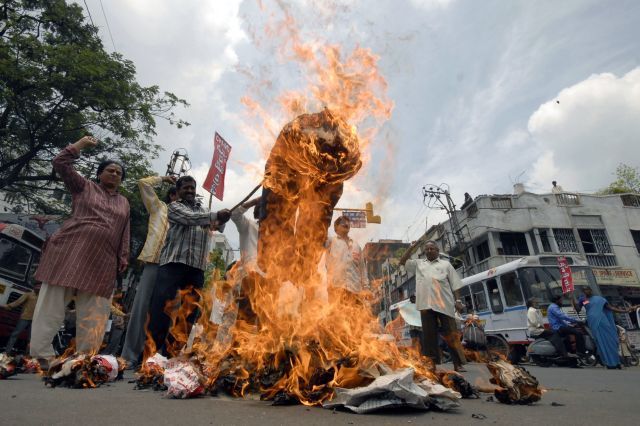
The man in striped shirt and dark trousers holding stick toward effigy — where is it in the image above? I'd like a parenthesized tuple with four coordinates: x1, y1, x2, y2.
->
(148, 176, 231, 354)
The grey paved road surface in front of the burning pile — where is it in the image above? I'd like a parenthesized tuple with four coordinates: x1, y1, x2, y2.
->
(0, 364, 640, 426)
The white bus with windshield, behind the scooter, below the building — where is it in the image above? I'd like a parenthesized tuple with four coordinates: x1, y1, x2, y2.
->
(455, 255, 600, 354)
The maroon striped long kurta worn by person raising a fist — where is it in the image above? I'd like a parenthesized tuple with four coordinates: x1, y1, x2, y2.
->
(35, 146, 129, 297)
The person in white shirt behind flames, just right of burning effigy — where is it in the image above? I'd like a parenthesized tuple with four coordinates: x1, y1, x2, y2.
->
(326, 216, 369, 300)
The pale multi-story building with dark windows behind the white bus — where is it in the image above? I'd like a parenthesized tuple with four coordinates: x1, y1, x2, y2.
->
(380, 185, 640, 328)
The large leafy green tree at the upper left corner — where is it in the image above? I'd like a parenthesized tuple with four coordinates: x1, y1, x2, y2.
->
(0, 0, 189, 205)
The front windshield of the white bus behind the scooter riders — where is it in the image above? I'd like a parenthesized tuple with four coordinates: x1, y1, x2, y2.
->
(518, 266, 600, 307)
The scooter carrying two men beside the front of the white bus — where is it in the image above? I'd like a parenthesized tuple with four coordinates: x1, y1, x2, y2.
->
(527, 324, 598, 367)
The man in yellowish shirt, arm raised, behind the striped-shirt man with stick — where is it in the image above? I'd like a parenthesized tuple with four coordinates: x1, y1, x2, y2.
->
(122, 176, 178, 368)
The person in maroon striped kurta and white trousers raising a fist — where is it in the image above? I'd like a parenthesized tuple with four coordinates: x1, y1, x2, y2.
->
(31, 136, 129, 358)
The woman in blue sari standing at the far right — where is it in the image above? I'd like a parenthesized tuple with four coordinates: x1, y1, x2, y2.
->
(575, 287, 628, 369)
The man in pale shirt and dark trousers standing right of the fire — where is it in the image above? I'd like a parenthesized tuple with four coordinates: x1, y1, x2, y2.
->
(400, 241, 466, 372)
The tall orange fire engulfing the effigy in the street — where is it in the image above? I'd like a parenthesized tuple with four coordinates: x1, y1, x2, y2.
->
(132, 0, 544, 405)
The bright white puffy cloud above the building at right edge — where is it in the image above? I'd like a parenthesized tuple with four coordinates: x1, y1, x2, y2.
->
(528, 67, 640, 191)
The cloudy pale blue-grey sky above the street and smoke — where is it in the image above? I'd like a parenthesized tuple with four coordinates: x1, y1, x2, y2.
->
(78, 0, 640, 255)
